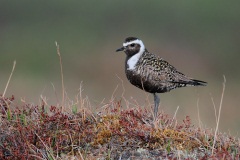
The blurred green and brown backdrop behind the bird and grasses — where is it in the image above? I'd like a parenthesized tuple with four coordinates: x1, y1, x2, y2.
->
(0, 0, 240, 135)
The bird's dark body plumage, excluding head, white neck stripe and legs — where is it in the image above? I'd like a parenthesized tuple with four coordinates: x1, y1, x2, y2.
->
(125, 51, 204, 93)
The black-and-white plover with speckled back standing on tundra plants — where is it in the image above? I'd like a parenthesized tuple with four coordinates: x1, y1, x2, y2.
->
(116, 37, 207, 118)
